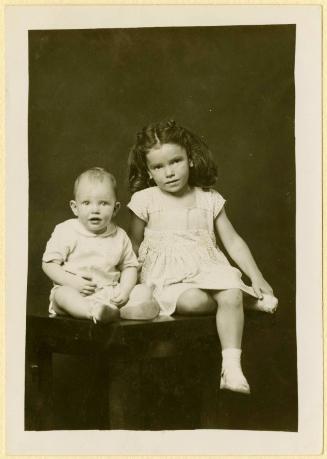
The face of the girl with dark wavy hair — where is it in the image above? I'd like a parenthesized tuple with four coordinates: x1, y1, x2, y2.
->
(146, 143, 190, 195)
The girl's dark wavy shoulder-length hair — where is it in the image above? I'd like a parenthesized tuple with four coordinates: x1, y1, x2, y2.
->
(128, 120, 217, 193)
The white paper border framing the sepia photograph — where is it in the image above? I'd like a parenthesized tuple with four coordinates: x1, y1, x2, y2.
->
(5, 5, 323, 455)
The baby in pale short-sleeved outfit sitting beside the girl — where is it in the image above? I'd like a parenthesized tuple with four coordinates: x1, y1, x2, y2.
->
(42, 167, 159, 323)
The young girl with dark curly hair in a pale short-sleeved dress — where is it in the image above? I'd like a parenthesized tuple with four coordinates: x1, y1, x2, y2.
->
(128, 121, 277, 394)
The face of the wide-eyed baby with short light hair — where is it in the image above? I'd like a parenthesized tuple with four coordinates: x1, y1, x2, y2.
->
(70, 177, 119, 234)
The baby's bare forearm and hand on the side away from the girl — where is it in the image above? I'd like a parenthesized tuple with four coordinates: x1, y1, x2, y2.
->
(42, 261, 96, 296)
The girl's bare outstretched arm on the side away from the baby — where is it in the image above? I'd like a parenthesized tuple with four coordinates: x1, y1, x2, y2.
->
(215, 209, 273, 298)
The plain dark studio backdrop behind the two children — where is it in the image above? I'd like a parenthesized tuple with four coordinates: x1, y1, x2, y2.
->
(27, 25, 297, 430)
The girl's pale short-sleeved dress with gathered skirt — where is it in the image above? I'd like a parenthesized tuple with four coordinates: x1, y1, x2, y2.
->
(128, 187, 256, 315)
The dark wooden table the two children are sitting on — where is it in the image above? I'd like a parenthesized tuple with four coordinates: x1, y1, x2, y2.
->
(25, 313, 280, 430)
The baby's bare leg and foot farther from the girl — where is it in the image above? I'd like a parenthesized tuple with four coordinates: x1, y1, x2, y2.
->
(53, 286, 119, 322)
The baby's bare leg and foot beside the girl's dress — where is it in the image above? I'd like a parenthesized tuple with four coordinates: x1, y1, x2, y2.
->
(120, 284, 160, 320)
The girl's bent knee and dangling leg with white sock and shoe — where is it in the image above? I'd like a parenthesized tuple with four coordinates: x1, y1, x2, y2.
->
(176, 288, 250, 394)
